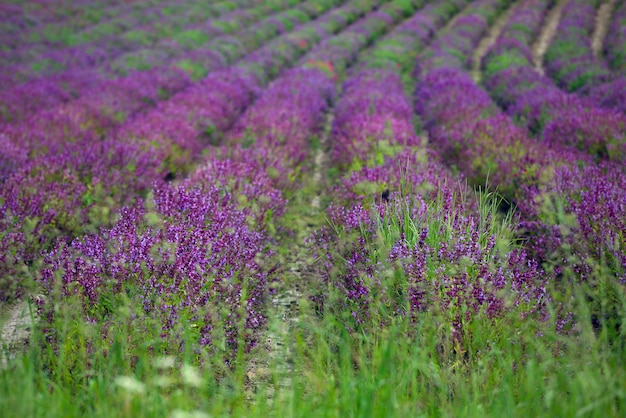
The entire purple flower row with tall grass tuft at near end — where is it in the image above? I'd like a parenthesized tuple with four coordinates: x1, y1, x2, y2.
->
(312, 1, 546, 347)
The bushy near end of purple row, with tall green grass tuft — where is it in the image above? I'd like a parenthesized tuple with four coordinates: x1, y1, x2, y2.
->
(313, 150, 547, 346)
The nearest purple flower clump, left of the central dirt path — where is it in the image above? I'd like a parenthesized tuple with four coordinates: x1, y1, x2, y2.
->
(40, 175, 276, 357)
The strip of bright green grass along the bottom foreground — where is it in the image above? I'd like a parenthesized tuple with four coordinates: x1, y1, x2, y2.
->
(0, 284, 626, 417)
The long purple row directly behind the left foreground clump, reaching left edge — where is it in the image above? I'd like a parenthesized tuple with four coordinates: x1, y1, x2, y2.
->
(1, 2, 371, 302)
